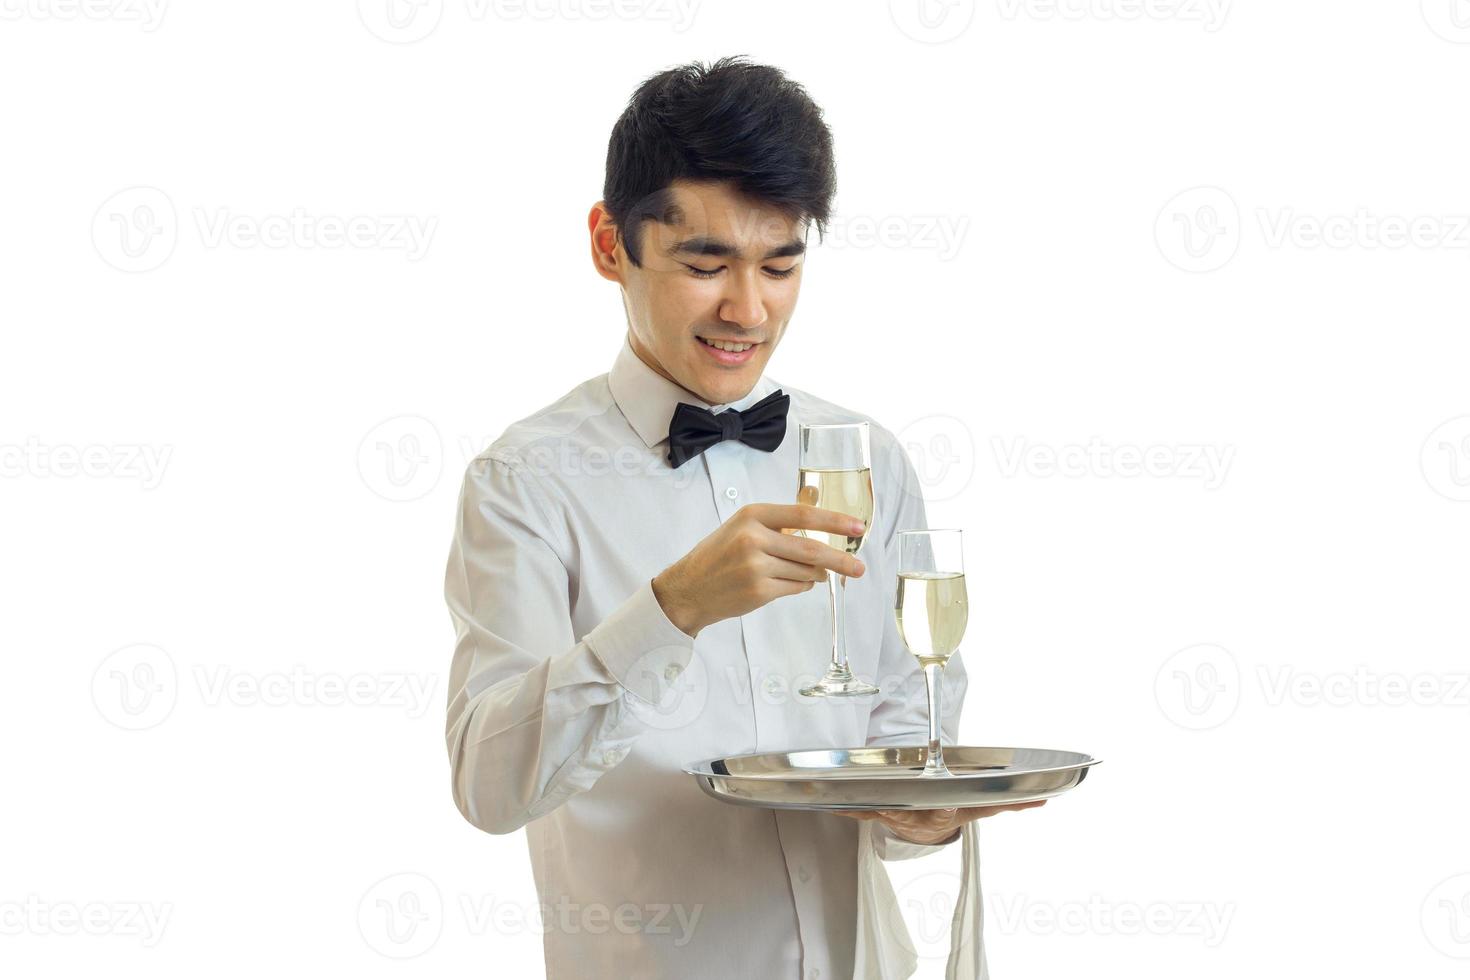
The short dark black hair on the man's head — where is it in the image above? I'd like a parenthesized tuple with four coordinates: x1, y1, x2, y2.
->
(603, 56, 836, 266)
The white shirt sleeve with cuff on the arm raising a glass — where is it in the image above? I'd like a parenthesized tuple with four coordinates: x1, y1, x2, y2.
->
(444, 457, 694, 833)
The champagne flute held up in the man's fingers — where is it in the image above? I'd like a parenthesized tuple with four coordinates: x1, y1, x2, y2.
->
(797, 422, 878, 698)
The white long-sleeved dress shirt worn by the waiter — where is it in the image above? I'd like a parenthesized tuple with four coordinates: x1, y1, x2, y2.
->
(445, 339, 973, 980)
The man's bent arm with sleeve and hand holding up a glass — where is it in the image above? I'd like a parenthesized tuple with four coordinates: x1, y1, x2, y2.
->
(444, 454, 863, 833)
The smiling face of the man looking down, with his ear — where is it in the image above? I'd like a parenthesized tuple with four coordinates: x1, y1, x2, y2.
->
(588, 181, 807, 404)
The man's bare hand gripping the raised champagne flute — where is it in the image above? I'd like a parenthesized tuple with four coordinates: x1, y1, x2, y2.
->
(653, 504, 864, 636)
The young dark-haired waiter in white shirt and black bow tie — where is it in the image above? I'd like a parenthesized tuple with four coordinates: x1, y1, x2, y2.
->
(445, 59, 1040, 980)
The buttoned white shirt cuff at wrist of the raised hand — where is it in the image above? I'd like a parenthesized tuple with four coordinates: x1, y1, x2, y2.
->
(584, 579, 694, 704)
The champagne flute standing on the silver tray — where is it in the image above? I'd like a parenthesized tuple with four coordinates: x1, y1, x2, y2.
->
(894, 529, 970, 776)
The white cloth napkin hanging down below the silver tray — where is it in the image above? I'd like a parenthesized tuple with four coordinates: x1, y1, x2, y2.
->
(853, 820, 991, 980)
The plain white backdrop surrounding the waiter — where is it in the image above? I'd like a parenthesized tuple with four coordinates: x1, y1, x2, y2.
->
(0, 0, 1470, 980)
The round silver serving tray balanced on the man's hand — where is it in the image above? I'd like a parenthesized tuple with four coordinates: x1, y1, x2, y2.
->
(684, 745, 1101, 810)
